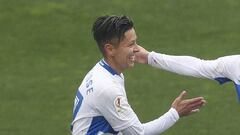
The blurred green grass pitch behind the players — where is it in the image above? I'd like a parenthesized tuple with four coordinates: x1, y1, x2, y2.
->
(0, 0, 240, 135)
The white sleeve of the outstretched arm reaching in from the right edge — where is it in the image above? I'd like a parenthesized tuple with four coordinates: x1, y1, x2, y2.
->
(148, 52, 240, 100)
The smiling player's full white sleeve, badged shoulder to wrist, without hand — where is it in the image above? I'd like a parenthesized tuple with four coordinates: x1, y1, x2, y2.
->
(94, 87, 179, 135)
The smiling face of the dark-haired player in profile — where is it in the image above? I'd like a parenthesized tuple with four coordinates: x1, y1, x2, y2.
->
(114, 28, 138, 72)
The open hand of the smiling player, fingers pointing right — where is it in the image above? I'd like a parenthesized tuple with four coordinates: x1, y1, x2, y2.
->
(172, 91, 206, 117)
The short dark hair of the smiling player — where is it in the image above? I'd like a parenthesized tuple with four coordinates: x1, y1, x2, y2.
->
(92, 15, 133, 55)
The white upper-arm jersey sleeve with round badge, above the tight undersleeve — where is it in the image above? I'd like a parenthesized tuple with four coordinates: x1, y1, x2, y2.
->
(96, 86, 140, 131)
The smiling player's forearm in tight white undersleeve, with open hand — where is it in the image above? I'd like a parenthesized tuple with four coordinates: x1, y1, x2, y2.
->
(123, 91, 206, 135)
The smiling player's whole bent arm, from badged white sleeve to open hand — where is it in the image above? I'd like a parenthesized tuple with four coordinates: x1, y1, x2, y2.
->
(97, 87, 205, 135)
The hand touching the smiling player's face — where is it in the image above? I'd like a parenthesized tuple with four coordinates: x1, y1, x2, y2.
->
(135, 45, 149, 64)
